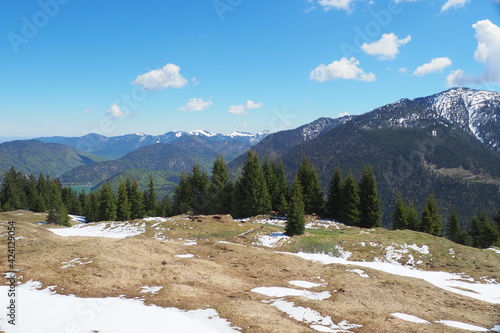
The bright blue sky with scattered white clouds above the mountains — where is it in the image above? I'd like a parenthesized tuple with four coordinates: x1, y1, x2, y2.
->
(0, 0, 500, 137)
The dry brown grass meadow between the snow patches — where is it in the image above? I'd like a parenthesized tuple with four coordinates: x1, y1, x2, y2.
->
(0, 212, 500, 333)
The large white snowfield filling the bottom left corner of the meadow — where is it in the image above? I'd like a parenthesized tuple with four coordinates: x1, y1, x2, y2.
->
(0, 281, 239, 333)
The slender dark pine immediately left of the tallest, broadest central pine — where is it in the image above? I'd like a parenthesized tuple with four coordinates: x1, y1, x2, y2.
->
(208, 155, 233, 214)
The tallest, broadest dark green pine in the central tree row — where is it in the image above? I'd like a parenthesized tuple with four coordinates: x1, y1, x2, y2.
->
(233, 150, 271, 217)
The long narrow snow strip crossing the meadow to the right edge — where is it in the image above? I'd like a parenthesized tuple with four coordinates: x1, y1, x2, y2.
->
(288, 252, 500, 304)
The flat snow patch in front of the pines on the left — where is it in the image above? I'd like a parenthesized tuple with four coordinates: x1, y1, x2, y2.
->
(48, 222, 146, 238)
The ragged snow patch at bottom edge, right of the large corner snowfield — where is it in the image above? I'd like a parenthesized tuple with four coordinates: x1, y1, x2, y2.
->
(270, 299, 363, 332)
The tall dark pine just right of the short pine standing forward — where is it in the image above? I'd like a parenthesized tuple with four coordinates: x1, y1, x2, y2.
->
(297, 157, 324, 215)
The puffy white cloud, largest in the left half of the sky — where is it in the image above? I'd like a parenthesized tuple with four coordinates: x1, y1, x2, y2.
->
(132, 64, 188, 91)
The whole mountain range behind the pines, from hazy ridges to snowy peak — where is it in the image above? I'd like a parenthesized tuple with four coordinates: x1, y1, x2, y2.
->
(0, 88, 500, 224)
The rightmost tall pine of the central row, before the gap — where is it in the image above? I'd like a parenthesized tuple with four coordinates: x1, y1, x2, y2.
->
(358, 166, 382, 228)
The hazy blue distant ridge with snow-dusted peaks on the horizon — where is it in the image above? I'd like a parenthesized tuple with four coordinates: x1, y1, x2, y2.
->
(37, 130, 269, 159)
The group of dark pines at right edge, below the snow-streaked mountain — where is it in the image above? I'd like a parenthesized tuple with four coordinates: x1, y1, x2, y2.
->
(392, 194, 500, 248)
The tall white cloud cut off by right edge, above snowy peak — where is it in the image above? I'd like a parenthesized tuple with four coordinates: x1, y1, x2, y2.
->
(446, 20, 500, 86)
